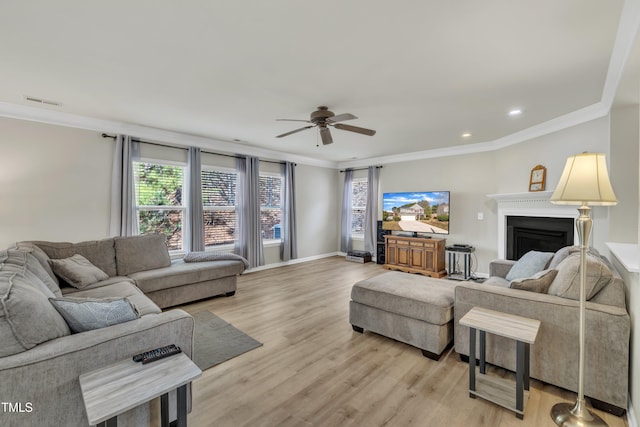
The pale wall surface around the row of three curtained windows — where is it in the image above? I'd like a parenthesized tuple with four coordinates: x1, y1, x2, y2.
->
(0, 118, 339, 264)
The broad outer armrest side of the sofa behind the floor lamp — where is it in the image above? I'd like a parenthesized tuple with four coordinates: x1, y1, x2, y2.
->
(454, 283, 631, 408)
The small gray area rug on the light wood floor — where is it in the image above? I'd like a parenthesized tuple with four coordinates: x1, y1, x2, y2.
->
(192, 310, 262, 371)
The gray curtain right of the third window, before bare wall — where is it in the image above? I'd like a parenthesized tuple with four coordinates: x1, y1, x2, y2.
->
(280, 162, 298, 261)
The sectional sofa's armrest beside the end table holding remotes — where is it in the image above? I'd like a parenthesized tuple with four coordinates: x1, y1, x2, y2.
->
(0, 310, 194, 426)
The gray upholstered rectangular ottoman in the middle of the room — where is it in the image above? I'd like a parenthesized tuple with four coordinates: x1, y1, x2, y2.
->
(349, 271, 457, 360)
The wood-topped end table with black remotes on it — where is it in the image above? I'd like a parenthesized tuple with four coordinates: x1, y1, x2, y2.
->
(80, 353, 202, 427)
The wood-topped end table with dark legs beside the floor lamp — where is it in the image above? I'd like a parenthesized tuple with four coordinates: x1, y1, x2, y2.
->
(460, 307, 540, 419)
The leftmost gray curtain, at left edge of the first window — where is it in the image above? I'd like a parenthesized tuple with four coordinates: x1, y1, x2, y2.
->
(109, 135, 140, 236)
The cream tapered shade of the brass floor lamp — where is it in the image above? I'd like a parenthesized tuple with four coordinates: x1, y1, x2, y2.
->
(550, 153, 618, 206)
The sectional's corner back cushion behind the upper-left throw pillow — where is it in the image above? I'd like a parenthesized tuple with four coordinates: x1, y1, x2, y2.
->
(30, 238, 118, 277)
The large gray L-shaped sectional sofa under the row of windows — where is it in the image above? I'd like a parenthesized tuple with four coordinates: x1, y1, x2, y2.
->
(0, 235, 245, 427)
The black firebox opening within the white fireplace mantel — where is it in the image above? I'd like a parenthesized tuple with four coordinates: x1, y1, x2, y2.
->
(506, 216, 574, 260)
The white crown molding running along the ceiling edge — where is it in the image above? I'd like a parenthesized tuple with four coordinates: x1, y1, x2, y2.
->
(0, 0, 640, 169)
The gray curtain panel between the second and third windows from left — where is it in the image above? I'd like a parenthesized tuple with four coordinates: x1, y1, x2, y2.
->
(235, 156, 264, 268)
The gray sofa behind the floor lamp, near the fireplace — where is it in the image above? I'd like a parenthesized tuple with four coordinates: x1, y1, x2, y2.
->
(454, 247, 631, 415)
